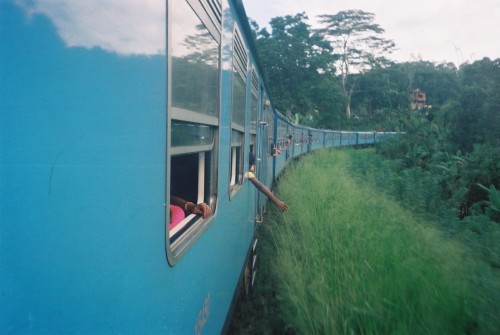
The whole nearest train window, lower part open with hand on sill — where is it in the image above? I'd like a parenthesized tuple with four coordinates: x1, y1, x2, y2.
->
(166, 0, 222, 265)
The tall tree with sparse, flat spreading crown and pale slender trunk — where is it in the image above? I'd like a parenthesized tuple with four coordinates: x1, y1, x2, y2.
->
(317, 10, 395, 118)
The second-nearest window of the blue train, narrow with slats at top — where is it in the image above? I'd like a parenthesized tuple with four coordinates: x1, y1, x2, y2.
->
(229, 27, 248, 194)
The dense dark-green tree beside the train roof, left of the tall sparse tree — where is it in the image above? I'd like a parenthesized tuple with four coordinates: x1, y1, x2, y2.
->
(253, 13, 335, 124)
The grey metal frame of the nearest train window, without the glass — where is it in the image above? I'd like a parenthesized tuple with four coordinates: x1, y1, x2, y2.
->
(164, 0, 222, 266)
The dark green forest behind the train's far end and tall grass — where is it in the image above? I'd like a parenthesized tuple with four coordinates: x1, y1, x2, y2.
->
(250, 10, 500, 228)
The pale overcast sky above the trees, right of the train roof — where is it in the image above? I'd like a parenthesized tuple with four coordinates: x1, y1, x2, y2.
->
(243, 0, 500, 66)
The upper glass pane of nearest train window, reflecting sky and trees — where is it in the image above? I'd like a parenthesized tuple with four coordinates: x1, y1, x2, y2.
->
(169, 0, 219, 116)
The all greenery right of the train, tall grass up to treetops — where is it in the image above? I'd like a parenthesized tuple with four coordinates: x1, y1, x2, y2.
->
(238, 11, 500, 334)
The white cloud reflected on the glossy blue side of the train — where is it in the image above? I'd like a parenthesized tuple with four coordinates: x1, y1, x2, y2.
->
(16, 0, 166, 55)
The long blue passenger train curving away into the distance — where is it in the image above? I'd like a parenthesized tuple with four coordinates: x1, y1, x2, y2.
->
(0, 0, 393, 334)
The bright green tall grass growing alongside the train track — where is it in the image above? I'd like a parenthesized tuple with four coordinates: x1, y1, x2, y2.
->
(232, 151, 471, 334)
